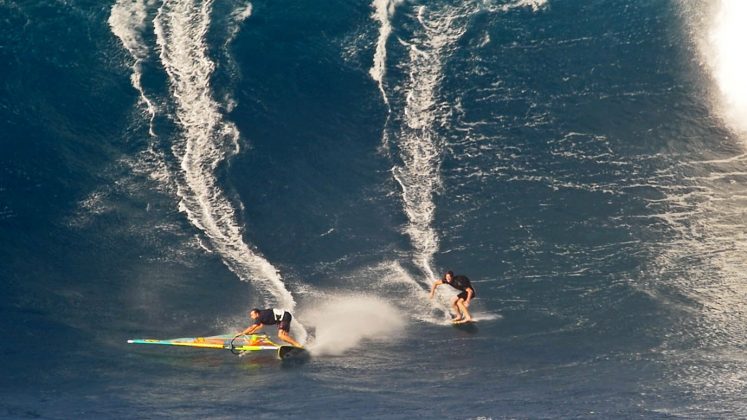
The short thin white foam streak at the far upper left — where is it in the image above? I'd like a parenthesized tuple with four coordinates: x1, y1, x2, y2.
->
(109, 0, 158, 137)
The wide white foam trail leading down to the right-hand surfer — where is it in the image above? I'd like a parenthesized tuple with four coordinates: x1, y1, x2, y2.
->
(392, 6, 466, 283)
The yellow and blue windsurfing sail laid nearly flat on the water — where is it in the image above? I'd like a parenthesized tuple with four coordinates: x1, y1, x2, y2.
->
(127, 334, 303, 359)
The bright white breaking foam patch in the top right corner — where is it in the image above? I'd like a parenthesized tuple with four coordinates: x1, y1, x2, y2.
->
(703, 0, 747, 134)
